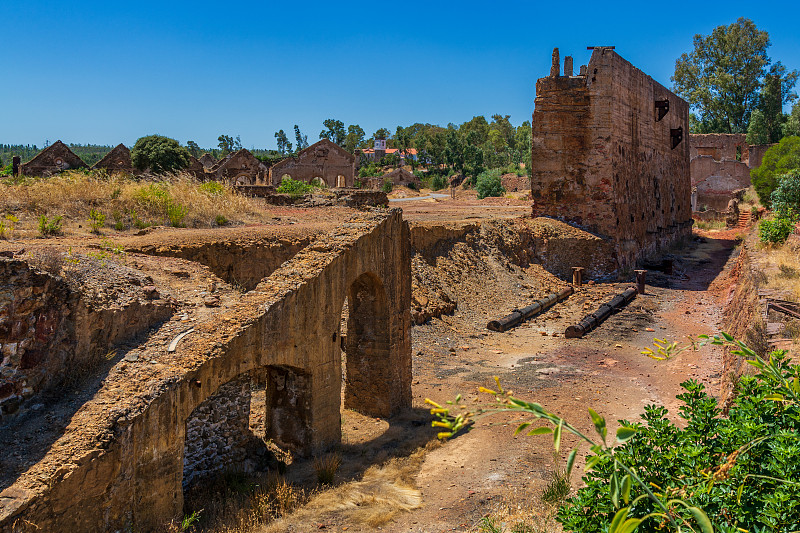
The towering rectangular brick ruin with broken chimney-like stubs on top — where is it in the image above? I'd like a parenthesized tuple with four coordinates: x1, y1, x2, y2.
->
(531, 48, 692, 275)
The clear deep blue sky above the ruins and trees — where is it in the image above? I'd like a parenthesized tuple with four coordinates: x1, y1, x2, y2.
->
(0, 0, 800, 148)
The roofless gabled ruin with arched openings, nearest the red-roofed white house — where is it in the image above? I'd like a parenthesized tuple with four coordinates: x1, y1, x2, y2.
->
(269, 139, 356, 187)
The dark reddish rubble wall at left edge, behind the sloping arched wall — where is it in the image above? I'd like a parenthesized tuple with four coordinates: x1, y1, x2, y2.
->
(0, 259, 173, 423)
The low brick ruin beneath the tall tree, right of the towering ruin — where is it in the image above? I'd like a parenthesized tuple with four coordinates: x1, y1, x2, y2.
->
(689, 133, 771, 211)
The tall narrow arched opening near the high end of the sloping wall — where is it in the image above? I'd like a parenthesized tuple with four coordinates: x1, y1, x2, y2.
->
(344, 272, 396, 416)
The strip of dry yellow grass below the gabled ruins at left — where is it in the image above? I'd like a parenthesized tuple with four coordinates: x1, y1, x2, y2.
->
(0, 168, 265, 230)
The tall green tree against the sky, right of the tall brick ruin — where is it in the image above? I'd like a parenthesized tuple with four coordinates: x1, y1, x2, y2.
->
(672, 18, 797, 133)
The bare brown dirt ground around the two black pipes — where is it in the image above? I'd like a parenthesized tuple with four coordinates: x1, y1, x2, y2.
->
(266, 202, 741, 532)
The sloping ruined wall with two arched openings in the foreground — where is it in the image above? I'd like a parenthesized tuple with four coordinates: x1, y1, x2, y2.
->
(0, 209, 412, 531)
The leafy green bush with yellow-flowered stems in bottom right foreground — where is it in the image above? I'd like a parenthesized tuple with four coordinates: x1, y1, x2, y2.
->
(426, 333, 800, 533)
